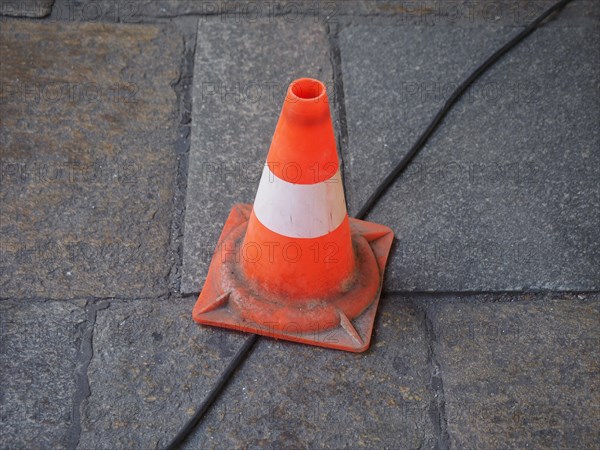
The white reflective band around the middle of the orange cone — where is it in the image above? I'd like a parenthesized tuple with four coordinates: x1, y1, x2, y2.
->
(254, 165, 347, 238)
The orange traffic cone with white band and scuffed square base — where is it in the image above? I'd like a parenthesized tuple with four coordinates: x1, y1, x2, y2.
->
(193, 78, 393, 352)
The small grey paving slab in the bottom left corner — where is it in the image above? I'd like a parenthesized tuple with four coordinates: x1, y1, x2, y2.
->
(0, 301, 86, 449)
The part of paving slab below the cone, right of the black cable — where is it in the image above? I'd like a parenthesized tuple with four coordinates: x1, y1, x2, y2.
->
(186, 297, 437, 449)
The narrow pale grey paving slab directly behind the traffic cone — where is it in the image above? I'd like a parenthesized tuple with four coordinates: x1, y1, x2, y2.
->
(181, 18, 336, 293)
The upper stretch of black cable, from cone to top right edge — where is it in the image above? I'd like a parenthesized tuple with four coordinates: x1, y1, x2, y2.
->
(356, 0, 573, 219)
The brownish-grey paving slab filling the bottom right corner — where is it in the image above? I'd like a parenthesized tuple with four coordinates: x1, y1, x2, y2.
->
(431, 295, 600, 449)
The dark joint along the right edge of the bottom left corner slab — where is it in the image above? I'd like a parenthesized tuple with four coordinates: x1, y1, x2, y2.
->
(67, 302, 110, 448)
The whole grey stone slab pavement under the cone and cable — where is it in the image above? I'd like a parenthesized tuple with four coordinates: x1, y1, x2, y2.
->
(0, 0, 600, 449)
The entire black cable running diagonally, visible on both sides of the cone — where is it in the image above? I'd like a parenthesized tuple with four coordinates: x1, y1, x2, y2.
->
(166, 0, 573, 450)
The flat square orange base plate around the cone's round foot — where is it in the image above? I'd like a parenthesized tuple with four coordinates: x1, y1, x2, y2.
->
(192, 204, 394, 352)
